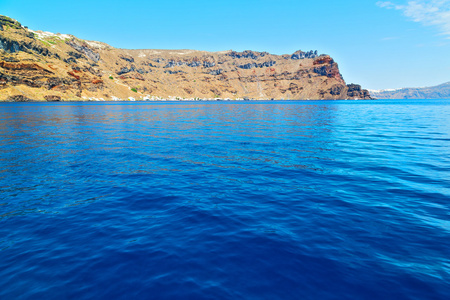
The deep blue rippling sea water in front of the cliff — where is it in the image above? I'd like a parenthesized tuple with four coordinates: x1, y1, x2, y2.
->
(0, 100, 450, 300)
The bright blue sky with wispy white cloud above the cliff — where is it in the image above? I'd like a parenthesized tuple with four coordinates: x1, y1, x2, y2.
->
(0, 0, 450, 89)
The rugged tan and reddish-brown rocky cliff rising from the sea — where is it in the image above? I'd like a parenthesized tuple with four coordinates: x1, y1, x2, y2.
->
(0, 16, 371, 101)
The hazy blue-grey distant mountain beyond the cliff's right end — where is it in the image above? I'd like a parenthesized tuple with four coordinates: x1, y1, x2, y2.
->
(369, 82, 450, 99)
